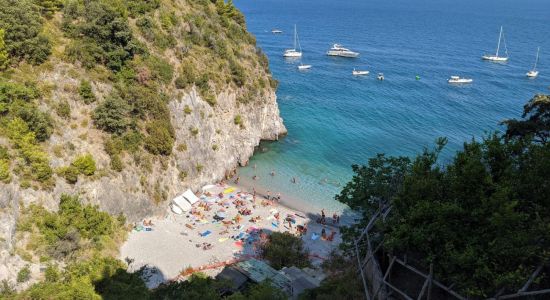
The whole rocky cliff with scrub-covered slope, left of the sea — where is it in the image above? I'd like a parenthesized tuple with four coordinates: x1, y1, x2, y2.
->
(0, 0, 286, 281)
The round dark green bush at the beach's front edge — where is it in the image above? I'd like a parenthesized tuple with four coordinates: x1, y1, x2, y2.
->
(261, 232, 310, 270)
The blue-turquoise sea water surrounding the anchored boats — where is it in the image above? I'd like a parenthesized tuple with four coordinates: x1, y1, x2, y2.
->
(235, 0, 550, 210)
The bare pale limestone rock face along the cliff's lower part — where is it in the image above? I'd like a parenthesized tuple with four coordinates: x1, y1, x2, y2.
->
(0, 85, 286, 289)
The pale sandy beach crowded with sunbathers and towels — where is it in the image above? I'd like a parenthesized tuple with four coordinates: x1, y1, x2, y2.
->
(120, 185, 341, 288)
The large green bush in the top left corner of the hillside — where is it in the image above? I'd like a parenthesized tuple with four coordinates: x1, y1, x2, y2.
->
(0, 0, 51, 64)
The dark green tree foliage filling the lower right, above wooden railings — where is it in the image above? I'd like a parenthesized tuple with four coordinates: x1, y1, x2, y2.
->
(336, 96, 550, 297)
